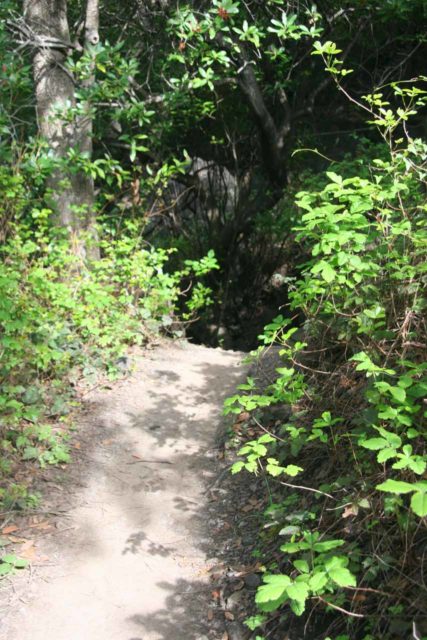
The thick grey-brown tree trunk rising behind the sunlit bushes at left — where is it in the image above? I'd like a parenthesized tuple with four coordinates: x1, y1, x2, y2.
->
(24, 0, 99, 259)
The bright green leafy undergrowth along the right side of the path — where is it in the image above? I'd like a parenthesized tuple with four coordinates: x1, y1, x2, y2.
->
(226, 89, 427, 640)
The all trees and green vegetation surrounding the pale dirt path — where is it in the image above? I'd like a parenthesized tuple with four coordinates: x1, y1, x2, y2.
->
(0, 0, 427, 640)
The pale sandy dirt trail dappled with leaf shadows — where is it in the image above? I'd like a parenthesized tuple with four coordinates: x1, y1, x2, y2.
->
(0, 344, 244, 640)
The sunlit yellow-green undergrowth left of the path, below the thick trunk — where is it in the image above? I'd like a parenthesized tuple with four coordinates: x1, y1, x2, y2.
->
(0, 212, 216, 510)
